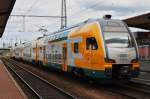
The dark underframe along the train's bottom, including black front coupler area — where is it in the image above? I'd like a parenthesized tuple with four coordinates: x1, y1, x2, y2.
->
(13, 59, 139, 80)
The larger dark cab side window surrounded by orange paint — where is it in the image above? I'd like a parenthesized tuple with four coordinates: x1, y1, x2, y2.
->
(86, 37, 98, 50)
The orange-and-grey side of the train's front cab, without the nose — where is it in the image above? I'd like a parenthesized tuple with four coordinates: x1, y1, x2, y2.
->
(68, 22, 109, 78)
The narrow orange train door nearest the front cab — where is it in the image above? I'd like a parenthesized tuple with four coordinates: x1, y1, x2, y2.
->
(62, 43, 67, 72)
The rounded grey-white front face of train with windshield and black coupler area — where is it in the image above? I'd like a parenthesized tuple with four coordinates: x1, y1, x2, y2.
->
(100, 19, 139, 79)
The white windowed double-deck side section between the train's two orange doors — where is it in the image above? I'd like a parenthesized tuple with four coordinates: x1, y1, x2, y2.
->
(45, 40, 66, 70)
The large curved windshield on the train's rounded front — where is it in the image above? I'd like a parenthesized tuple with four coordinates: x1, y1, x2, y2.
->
(104, 21, 134, 48)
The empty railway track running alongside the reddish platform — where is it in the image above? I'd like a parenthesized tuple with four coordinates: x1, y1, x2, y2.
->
(2, 59, 75, 99)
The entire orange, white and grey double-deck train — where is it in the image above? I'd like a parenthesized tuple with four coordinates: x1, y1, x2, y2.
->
(14, 15, 139, 79)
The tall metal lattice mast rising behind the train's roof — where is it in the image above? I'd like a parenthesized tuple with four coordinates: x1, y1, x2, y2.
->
(60, 0, 67, 29)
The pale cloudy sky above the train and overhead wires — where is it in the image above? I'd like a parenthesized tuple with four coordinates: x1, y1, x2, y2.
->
(0, 0, 150, 47)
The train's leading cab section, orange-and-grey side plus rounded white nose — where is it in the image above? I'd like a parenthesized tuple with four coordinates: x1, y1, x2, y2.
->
(67, 19, 139, 79)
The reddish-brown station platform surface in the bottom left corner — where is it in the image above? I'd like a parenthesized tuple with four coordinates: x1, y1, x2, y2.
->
(0, 60, 27, 99)
